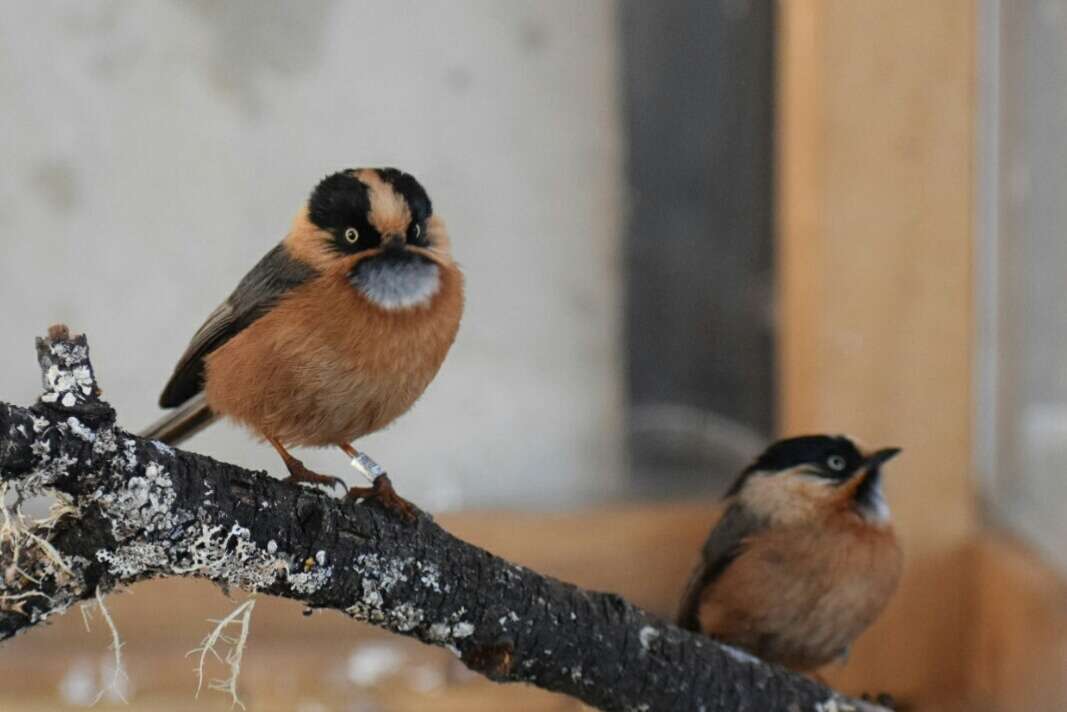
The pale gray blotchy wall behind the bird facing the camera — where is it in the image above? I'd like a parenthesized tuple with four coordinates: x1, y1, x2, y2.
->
(0, 0, 622, 508)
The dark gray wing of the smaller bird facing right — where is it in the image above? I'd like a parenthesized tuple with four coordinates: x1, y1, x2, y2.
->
(678, 500, 766, 631)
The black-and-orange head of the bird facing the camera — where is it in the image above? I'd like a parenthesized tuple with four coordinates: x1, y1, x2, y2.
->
(286, 168, 452, 311)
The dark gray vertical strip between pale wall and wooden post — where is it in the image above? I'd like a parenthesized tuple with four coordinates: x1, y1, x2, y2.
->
(620, 0, 776, 494)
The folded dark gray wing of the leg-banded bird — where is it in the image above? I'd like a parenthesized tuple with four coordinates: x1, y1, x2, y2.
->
(159, 243, 317, 408)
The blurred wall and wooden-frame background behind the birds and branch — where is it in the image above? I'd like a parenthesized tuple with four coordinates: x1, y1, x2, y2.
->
(0, 0, 1067, 712)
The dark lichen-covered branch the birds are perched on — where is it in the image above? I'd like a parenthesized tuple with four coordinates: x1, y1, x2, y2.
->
(0, 328, 877, 712)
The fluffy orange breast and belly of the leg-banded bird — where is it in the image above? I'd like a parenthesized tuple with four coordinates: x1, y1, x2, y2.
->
(204, 265, 463, 446)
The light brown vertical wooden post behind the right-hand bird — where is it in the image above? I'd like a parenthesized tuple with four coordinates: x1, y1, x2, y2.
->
(778, 0, 976, 700)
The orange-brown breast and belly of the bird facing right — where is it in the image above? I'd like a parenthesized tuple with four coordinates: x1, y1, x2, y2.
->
(699, 513, 901, 670)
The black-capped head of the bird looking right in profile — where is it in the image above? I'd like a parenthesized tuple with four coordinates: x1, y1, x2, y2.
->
(727, 434, 901, 522)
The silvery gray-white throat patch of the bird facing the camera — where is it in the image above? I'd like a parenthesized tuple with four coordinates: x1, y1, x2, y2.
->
(351, 254, 441, 311)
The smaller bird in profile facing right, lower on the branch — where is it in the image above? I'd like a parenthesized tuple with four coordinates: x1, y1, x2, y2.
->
(676, 434, 902, 673)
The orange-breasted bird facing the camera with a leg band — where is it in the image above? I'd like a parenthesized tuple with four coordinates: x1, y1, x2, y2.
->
(141, 168, 464, 515)
